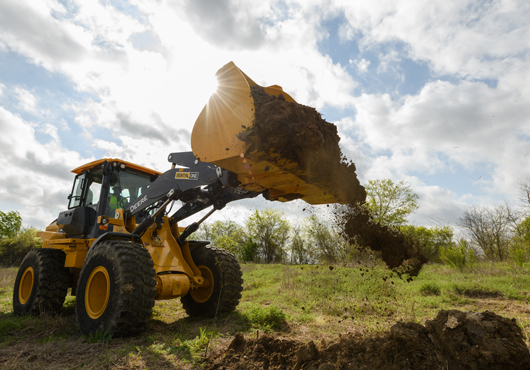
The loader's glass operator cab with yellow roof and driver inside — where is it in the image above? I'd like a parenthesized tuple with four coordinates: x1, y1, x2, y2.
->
(57, 159, 160, 238)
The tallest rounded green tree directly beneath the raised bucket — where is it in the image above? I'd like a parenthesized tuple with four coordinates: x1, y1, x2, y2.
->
(247, 209, 290, 263)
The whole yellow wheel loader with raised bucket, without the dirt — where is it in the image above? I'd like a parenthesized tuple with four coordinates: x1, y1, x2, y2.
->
(13, 62, 335, 336)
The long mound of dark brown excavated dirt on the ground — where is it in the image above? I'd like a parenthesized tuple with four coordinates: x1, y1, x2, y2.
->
(206, 310, 530, 370)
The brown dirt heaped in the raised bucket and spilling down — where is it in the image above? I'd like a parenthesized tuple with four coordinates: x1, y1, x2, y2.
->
(244, 86, 427, 276)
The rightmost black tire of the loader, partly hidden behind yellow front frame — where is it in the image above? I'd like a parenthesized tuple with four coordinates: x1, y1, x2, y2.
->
(180, 245, 243, 317)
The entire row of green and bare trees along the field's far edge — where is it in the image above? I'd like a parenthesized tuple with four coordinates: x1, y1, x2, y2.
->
(0, 180, 530, 267)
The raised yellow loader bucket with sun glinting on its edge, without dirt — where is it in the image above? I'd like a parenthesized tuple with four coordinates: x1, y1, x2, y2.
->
(191, 62, 338, 204)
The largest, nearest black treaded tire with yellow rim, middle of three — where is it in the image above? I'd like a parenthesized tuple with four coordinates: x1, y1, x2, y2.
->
(75, 240, 156, 337)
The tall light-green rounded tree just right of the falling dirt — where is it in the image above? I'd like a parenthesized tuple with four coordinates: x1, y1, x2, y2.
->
(364, 180, 419, 226)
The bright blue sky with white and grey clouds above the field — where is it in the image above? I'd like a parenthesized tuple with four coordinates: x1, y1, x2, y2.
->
(0, 0, 530, 228)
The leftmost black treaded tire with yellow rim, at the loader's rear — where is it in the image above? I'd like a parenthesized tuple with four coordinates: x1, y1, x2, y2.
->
(13, 248, 72, 316)
